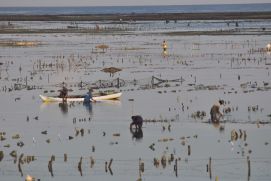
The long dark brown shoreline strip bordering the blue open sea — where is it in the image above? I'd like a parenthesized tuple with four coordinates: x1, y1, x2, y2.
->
(0, 11, 271, 23)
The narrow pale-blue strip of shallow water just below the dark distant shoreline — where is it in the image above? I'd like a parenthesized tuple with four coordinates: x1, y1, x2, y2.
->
(3, 19, 271, 33)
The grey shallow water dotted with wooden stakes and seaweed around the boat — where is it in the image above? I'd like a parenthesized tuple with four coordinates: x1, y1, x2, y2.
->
(0, 20, 271, 181)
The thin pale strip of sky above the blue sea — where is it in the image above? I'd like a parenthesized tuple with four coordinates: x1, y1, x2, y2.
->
(0, 0, 271, 7)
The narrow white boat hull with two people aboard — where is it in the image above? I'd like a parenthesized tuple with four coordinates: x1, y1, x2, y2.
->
(40, 92, 122, 102)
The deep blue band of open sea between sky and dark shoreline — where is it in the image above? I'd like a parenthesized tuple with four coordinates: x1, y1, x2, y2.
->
(0, 3, 271, 15)
